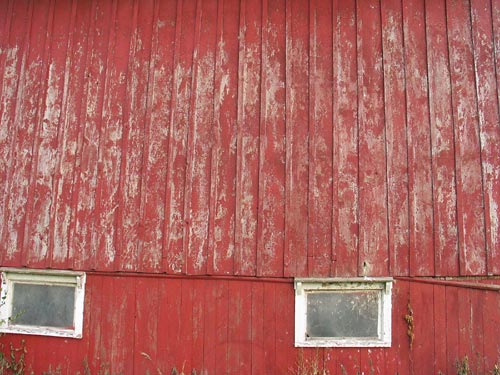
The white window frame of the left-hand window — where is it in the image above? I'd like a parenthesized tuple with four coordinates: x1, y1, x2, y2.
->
(0, 268, 86, 338)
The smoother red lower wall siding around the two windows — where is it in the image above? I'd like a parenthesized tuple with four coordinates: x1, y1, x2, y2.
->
(0, 274, 500, 375)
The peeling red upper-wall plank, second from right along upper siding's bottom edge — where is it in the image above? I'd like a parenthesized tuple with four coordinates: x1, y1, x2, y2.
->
(446, 0, 486, 275)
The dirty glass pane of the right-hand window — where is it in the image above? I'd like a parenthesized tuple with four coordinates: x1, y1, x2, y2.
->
(307, 291, 380, 338)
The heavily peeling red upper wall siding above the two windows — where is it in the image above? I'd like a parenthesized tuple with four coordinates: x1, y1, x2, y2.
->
(0, 0, 500, 277)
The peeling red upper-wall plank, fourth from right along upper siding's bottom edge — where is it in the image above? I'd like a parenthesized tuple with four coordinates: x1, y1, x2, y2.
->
(403, 1, 434, 275)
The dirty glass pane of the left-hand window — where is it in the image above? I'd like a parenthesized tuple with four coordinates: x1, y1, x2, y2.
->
(12, 283, 75, 328)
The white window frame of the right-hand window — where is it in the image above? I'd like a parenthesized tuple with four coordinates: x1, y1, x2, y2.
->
(294, 277, 393, 347)
